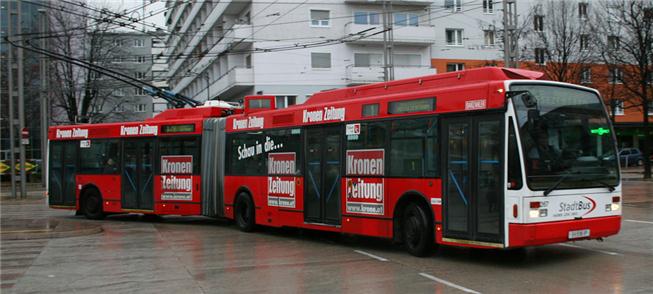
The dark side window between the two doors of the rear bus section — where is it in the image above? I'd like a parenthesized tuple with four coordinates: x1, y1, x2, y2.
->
(79, 140, 120, 174)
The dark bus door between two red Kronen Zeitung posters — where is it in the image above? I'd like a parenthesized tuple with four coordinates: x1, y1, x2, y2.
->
(304, 127, 342, 225)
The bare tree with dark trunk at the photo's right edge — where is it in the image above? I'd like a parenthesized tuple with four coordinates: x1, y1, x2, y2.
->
(591, 0, 653, 179)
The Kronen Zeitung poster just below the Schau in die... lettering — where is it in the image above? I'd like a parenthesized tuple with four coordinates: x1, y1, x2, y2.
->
(267, 152, 297, 208)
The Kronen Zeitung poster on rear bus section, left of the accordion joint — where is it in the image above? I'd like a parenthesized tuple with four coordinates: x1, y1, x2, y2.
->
(161, 155, 193, 201)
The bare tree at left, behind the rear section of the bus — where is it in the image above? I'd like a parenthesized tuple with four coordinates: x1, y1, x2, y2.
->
(48, 7, 137, 123)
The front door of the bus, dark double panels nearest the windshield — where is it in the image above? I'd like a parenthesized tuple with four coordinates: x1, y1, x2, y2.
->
(441, 115, 504, 247)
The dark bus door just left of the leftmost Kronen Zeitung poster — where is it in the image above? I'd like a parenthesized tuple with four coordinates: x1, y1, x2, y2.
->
(121, 139, 154, 210)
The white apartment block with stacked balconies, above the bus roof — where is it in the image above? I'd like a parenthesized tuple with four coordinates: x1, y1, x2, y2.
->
(165, 0, 437, 107)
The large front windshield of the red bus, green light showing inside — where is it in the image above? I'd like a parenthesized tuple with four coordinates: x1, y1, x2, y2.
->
(510, 84, 619, 194)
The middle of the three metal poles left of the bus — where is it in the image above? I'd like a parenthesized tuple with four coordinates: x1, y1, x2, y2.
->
(16, 0, 27, 198)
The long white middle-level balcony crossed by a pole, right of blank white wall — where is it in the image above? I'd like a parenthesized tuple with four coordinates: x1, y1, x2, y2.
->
(345, 22, 435, 46)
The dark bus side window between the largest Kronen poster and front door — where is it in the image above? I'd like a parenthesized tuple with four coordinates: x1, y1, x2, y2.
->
(386, 118, 438, 177)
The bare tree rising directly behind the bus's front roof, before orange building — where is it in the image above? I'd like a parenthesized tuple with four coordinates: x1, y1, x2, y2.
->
(521, 0, 595, 83)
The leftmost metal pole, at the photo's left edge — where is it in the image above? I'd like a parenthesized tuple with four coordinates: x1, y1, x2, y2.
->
(7, 1, 18, 198)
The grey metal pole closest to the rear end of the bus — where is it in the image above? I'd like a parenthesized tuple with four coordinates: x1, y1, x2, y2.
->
(39, 9, 49, 187)
